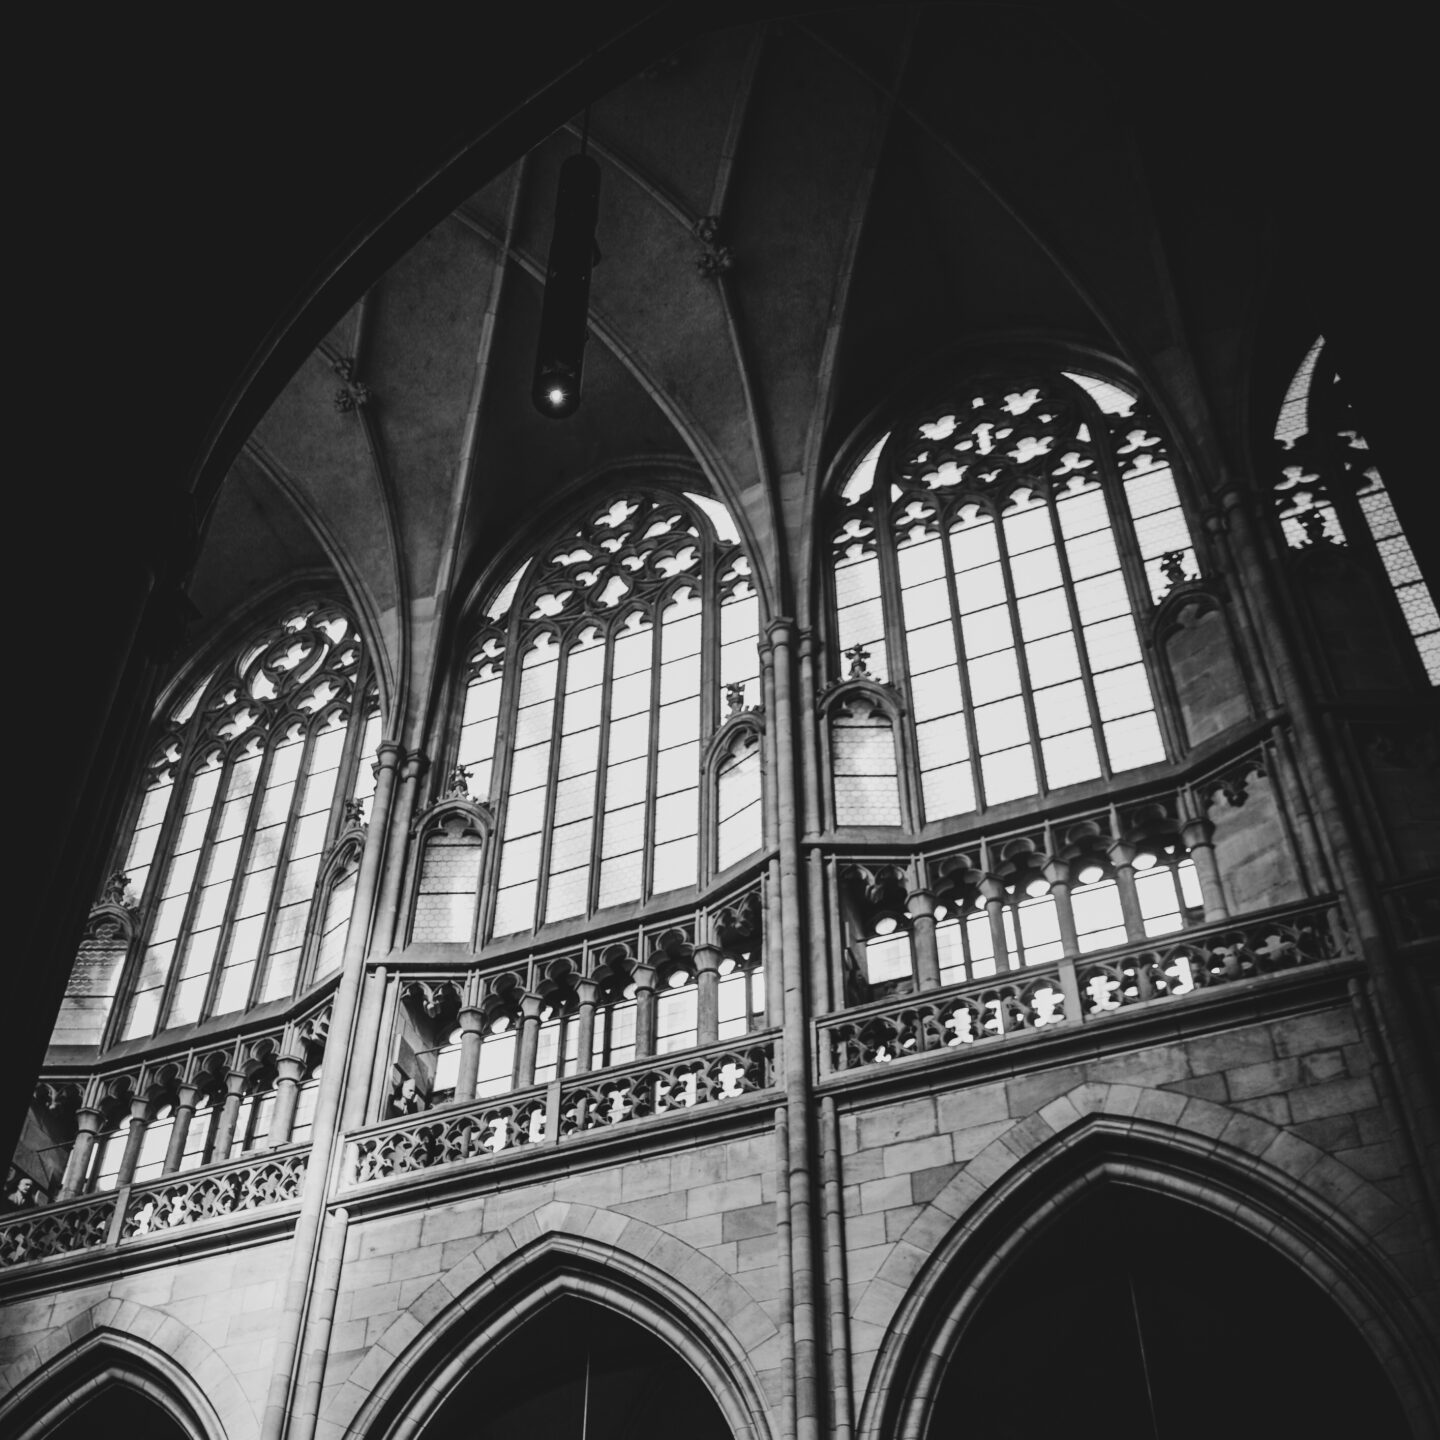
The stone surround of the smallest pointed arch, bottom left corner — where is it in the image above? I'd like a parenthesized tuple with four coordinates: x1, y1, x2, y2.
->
(0, 1299, 241, 1440)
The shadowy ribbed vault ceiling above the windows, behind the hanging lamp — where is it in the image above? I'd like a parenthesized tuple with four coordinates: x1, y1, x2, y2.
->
(192, 6, 1284, 731)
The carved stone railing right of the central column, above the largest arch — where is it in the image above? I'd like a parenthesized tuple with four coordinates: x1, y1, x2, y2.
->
(818, 901, 1351, 1074)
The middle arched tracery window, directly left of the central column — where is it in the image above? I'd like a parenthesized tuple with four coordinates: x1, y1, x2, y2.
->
(456, 491, 760, 937)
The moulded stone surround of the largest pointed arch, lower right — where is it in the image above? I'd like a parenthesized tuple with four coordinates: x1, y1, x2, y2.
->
(857, 1105, 1440, 1440)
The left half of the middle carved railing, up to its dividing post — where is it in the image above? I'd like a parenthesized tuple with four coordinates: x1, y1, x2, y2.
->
(346, 1086, 546, 1185)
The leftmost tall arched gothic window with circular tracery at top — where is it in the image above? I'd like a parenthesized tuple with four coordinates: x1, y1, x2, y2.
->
(97, 600, 380, 1040)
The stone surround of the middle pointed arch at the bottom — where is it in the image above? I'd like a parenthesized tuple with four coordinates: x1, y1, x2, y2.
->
(332, 1201, 782, 1440)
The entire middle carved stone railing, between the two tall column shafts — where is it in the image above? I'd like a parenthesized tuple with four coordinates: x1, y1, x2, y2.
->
(344, 1031, 776, 1185)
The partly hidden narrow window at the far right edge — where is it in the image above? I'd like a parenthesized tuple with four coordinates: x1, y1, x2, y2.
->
(1274, 336, 1440, 685)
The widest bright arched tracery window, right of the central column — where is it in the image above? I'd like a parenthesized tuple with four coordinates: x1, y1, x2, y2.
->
(829, 370, 1197, 821)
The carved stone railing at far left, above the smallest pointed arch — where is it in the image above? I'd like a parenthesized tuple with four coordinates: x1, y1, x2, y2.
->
(0, 1146, 310, 1267)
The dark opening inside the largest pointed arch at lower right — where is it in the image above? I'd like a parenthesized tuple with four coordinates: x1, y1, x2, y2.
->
(924, 1182, 1411, 1440)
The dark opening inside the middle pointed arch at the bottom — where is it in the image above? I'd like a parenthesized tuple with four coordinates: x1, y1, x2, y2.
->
(420, 1296, 732, 1440)
